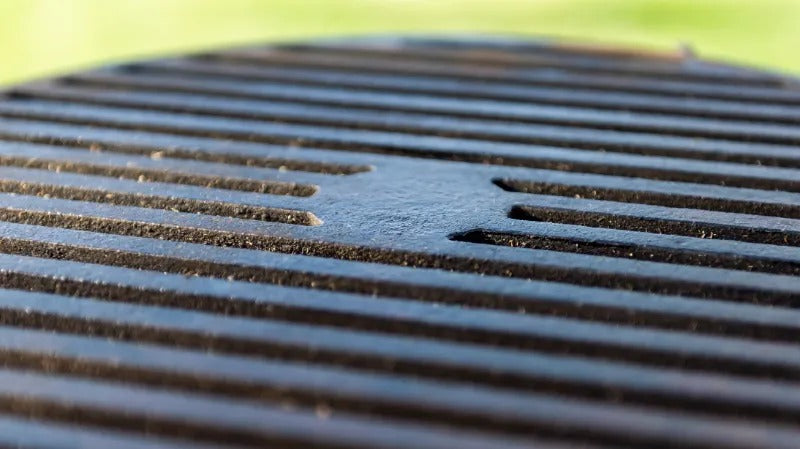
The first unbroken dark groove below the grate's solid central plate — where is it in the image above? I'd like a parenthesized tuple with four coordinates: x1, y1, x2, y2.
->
(0, 209, 800, 307)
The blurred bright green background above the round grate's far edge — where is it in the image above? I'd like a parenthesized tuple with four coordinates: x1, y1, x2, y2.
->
(0, 0, 800, 84)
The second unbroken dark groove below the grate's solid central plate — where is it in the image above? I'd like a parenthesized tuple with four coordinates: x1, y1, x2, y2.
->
(0, 234, 800, 341)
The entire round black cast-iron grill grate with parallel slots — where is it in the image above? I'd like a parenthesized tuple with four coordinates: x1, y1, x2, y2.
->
(0, 38, 800, 449)
